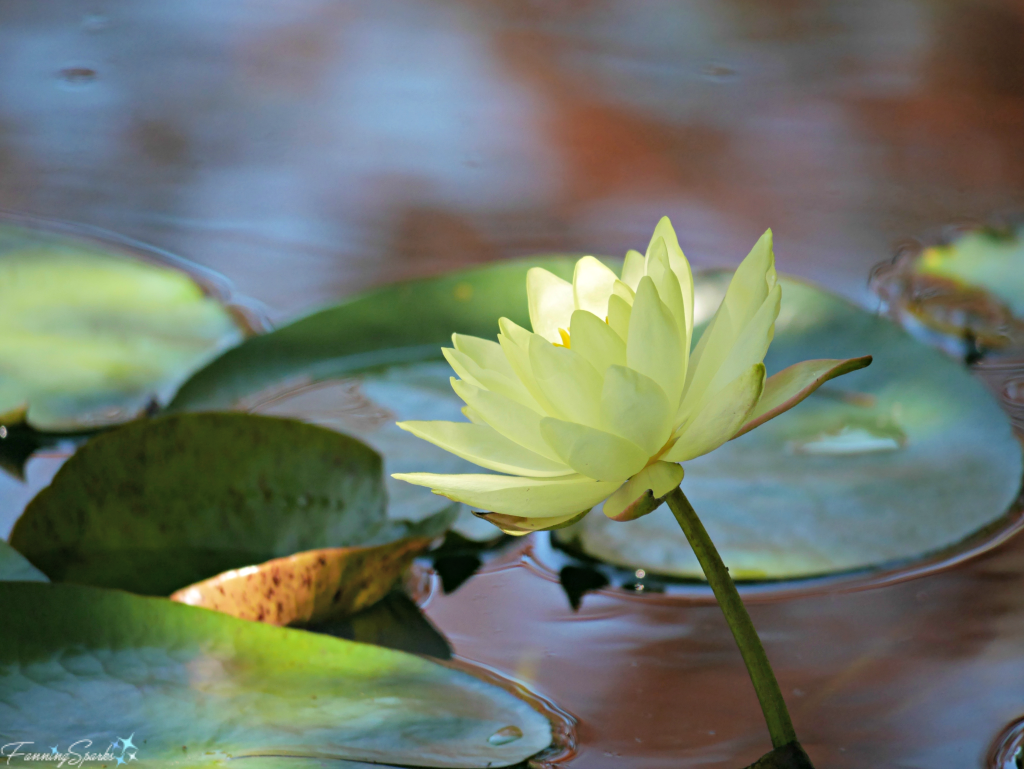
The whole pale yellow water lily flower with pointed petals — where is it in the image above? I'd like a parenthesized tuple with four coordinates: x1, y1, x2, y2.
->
(394, 217, 870, 535)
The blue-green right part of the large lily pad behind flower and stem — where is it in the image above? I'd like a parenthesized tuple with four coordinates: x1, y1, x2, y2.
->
(554, 273, 1024, 580)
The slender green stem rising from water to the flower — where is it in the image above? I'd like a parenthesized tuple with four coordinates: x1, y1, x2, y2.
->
(666, 486, 797, 747)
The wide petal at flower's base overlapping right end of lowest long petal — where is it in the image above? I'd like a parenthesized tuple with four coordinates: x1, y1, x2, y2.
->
(541, 417, 648, 482)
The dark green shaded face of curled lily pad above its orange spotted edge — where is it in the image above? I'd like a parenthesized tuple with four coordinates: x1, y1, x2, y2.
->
(9, 414, 452, 595)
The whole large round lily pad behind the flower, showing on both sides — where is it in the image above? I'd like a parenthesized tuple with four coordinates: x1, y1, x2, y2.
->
(172, 257, 1022, 565)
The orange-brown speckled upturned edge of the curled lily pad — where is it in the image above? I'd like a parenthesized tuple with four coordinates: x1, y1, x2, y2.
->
(171, 538, 430, 626)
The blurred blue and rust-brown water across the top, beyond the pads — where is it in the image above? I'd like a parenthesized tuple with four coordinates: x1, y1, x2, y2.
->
(0, 0, 1024, 319)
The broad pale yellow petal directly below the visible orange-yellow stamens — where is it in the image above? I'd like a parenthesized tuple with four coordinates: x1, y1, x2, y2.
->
(529, 336, 601, 425)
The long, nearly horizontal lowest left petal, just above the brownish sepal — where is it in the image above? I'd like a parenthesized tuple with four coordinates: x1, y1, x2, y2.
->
(391, 473, 618, 518)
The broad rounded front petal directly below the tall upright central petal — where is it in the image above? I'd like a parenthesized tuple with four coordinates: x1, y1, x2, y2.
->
(601, 366, 675, 457)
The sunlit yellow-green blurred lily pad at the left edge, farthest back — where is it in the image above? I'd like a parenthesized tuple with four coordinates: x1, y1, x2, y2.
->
(0, 224, 246, 431)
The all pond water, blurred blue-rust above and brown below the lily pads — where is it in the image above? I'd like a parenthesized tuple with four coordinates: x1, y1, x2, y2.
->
(0, 0, 1024, 769)
